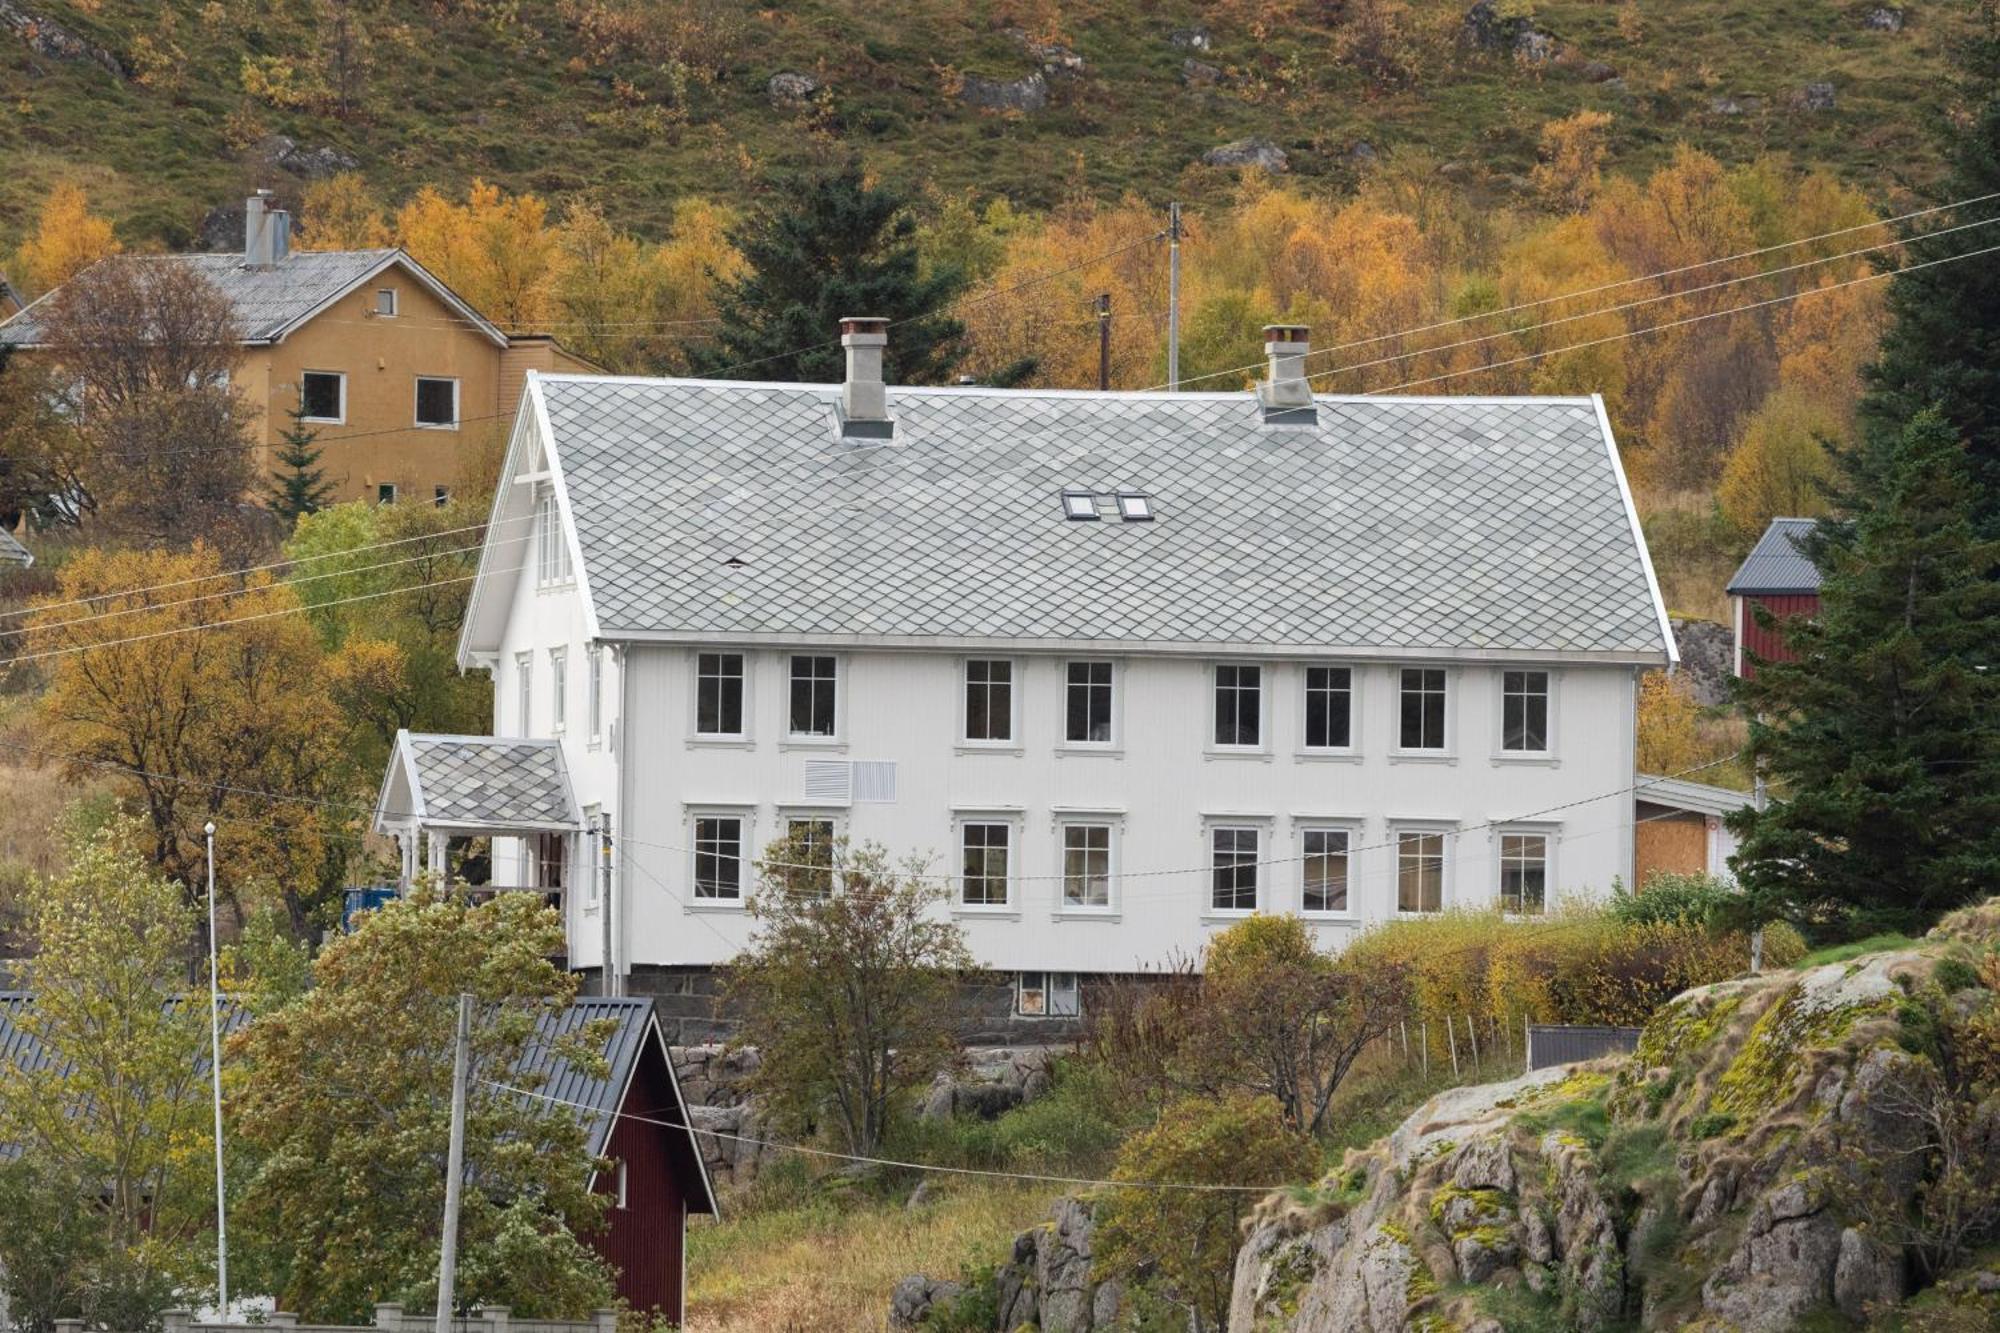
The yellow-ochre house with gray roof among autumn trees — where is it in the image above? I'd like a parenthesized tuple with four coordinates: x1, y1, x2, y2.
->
(0, 192, 596, 504)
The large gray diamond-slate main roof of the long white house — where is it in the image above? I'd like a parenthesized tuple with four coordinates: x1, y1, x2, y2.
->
(540, 376, 1666, 656)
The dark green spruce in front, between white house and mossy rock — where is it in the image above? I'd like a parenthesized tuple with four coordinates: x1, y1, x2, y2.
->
(1730, 412, 2000, 931)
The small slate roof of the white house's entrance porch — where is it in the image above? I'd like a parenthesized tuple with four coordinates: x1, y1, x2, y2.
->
(386, 735, 578, 829)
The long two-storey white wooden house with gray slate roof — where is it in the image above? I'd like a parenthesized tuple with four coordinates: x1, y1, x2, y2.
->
(378, 320, 1674, 1040)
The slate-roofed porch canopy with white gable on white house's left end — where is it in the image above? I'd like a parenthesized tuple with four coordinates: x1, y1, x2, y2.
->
(374, 731, 584, 891)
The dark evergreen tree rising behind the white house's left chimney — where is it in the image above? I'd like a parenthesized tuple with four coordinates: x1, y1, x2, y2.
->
(692, 158, 966, 384)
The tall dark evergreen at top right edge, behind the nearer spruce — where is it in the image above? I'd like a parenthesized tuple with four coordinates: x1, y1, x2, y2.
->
(1840, 0, 2000, 534)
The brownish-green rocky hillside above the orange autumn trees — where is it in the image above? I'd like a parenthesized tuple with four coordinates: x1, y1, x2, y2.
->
(0, 0, 1972, 246)
